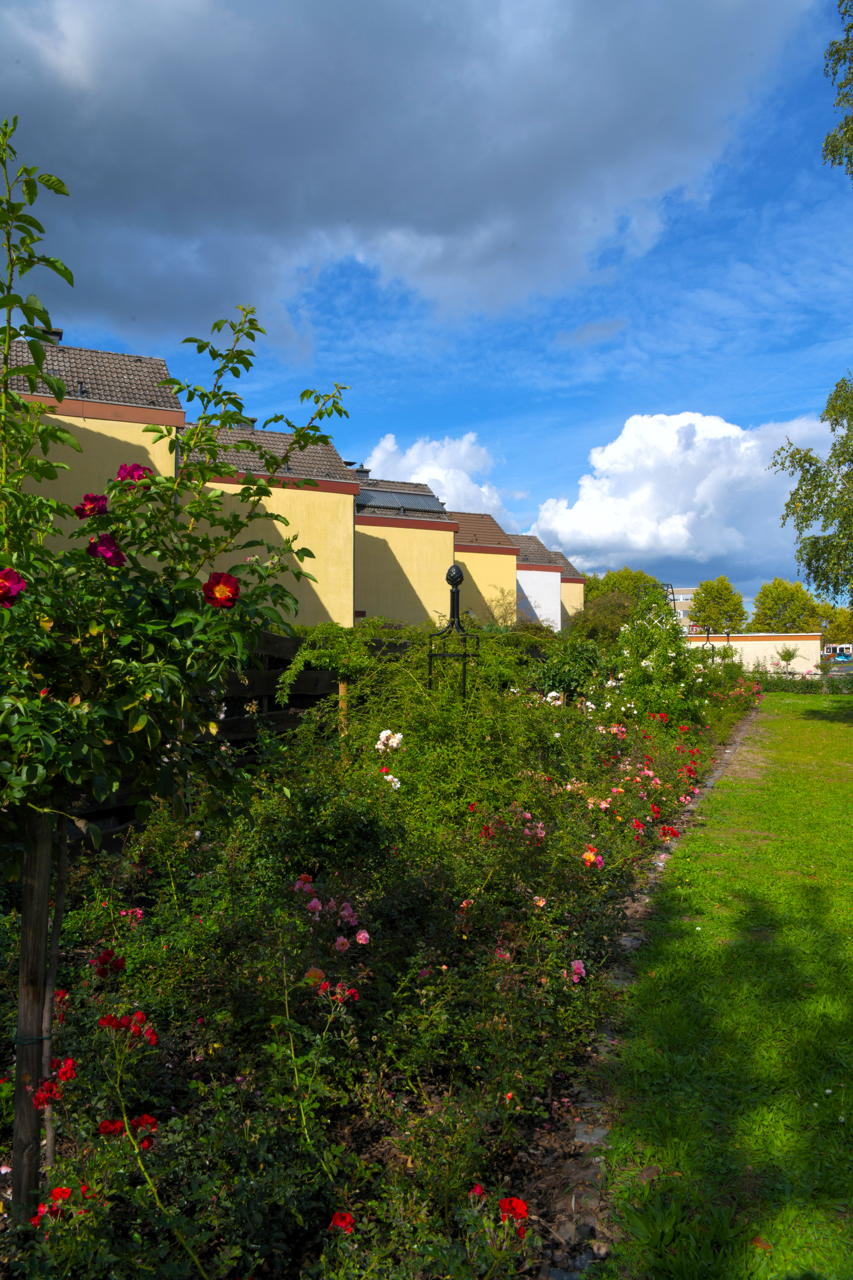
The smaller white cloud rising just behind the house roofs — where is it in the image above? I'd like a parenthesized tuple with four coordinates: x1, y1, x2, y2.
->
(365, 431, 506, 520)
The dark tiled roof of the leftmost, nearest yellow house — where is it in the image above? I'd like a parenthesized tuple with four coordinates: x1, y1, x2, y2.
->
(12, 342, 183, 412)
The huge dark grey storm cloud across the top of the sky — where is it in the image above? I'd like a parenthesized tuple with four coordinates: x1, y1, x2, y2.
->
(0, 0, 820, 338)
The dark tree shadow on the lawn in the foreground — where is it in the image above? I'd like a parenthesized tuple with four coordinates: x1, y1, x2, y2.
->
(594, 884, 853, 1280)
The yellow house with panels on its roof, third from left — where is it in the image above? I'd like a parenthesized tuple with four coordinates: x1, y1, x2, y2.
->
(351, 467, 457, 625)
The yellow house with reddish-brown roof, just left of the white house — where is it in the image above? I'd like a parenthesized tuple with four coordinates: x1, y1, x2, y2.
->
(448, 511, 519, 626)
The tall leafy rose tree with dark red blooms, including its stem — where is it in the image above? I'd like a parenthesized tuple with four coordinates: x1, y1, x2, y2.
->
(0, 118, 346, 1211)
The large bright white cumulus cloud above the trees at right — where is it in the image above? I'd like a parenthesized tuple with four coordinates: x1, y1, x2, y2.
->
(533, 412, 829, 581)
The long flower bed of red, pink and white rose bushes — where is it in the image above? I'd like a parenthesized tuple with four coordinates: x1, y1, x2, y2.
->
(0, 614, 757, 1280)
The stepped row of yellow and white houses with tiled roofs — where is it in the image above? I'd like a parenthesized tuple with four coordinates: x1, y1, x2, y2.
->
(13, 334, 584, 631)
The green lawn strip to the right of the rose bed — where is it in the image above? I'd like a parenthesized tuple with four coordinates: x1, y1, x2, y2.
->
(598, 694, 853, 1280)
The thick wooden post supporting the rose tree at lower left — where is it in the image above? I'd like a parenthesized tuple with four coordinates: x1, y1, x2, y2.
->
(12, 810, 53, 1220)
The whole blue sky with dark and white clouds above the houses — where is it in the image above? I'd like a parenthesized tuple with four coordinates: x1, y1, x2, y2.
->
(0, 0, 853, 598)
